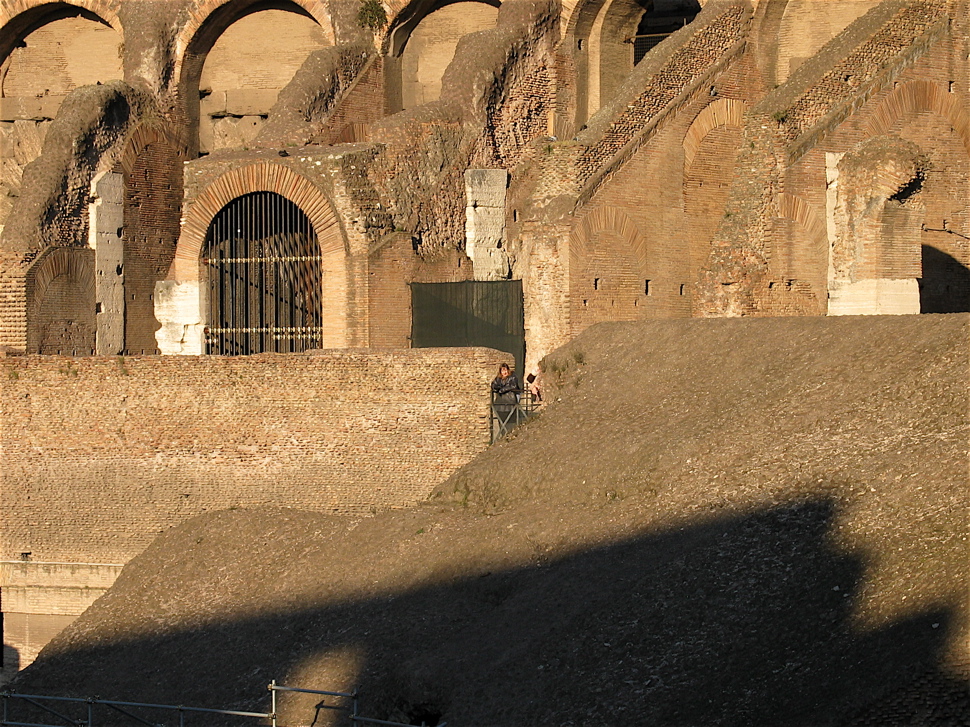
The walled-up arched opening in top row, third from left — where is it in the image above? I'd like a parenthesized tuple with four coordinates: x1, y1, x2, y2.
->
(388, 1, 498, 112)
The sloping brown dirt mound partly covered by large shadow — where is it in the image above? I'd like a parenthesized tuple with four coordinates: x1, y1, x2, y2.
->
(9, 315, 970, 727)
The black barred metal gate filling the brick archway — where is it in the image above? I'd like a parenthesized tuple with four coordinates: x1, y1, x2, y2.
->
(202, 192, 323, 356)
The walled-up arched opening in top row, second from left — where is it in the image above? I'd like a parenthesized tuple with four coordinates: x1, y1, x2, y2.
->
(182, 0, 330, 154)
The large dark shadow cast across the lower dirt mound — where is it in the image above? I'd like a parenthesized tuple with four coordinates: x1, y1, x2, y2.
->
(9, 499, 970, 727)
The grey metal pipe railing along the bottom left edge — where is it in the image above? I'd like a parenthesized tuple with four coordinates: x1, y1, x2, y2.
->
(0, 680, 447, 727)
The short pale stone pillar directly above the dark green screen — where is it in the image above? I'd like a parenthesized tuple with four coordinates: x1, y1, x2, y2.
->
(465, 169, 509, 280)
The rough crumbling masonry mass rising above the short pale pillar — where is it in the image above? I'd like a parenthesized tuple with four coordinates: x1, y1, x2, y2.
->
(370, 0, 558, 258)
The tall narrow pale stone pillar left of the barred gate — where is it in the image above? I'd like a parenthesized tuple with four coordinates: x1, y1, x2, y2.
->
(88, 172, 125, 356)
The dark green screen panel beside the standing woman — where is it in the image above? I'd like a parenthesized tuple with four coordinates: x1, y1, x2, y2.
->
(411, 280, 525, 379)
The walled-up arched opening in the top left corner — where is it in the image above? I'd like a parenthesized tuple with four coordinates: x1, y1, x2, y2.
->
(0, 3, 124, 225)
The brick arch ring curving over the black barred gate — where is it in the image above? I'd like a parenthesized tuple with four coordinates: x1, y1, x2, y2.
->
(173, 162, 348, 281)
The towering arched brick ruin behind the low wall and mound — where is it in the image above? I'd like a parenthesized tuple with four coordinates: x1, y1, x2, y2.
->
(0, 0, 970, 684)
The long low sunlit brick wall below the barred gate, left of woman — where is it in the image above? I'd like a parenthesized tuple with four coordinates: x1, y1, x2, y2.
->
(0, 348, 504, 563)
